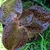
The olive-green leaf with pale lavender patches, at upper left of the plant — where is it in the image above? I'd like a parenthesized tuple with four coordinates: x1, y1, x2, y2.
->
(0, 0, 22, 25)
